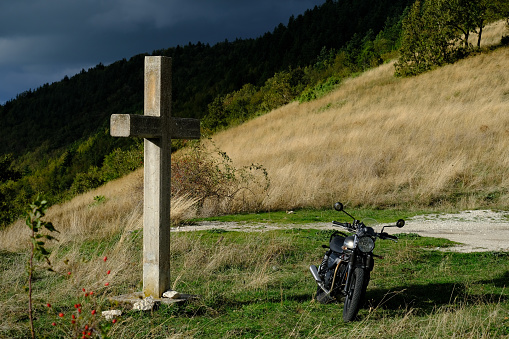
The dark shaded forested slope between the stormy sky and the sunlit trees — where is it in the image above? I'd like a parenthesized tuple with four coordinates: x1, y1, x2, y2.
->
(0, 0, 413, 156)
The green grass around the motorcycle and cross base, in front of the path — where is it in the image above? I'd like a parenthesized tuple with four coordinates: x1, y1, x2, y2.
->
(0, 230, 509, 338)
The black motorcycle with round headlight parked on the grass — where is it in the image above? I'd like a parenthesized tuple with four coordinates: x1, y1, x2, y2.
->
(309, 202, 405, 322)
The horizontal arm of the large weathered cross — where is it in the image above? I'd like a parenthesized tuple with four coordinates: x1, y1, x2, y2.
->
(110, 114, 200, 139)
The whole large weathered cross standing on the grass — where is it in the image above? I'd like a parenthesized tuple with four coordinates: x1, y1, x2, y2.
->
(110, 56, 200, 298)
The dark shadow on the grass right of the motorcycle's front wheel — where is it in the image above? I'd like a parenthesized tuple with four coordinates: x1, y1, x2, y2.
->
(365, 271, 509, 313)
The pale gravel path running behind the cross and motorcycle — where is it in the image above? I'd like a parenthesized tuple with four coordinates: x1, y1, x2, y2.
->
(174, 210, 509, 252)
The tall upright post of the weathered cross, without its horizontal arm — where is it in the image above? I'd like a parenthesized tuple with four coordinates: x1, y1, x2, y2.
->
(143, 57, 171, 298)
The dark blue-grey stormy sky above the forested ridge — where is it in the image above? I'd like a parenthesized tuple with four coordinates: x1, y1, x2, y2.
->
(0, 0, 325, 104)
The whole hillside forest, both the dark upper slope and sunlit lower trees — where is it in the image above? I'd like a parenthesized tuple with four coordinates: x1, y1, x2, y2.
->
(0, 0, 503, 227)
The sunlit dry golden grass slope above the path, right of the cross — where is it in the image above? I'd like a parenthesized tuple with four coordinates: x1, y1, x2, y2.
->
(210, 25, 509, 209)
